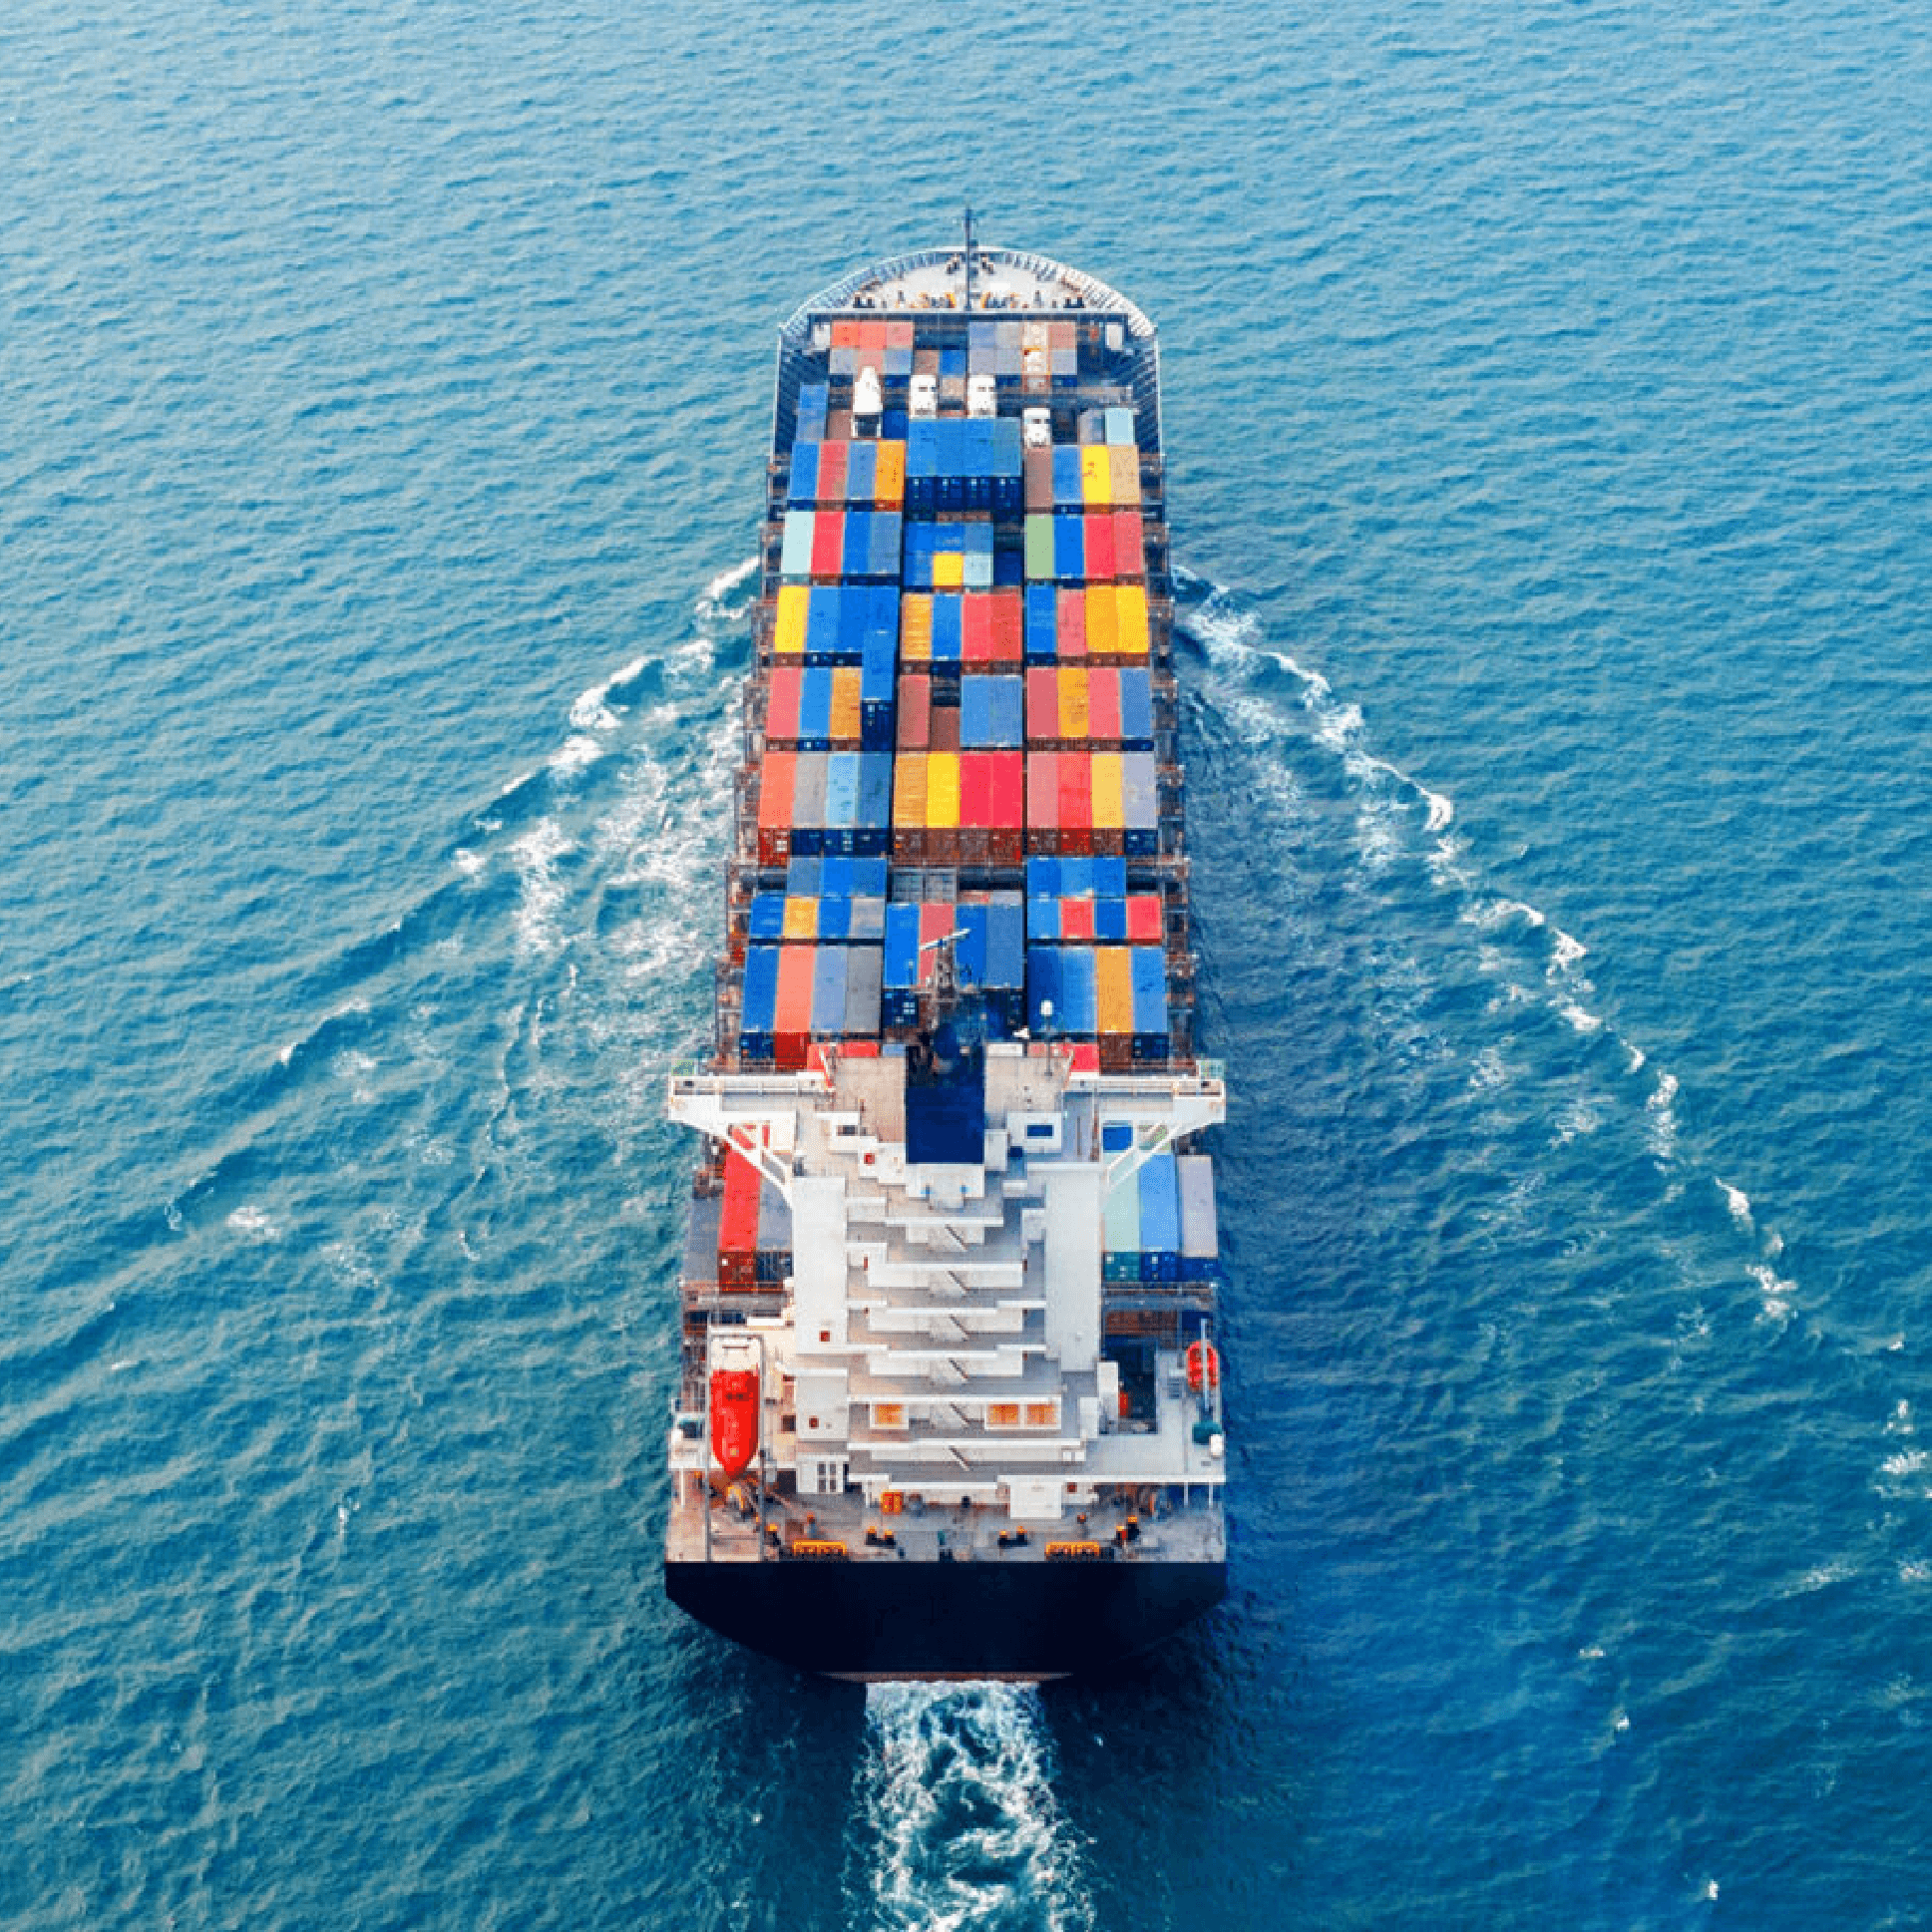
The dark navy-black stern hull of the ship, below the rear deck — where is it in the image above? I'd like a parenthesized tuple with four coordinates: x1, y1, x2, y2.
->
(664, 1561, 1227, 1679)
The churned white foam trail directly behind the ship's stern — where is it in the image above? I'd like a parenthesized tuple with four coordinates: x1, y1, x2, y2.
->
(852, 1683, 1093, 1932)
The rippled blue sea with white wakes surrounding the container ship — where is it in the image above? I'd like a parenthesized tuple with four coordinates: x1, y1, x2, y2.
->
(0, 0, 1932, 1932)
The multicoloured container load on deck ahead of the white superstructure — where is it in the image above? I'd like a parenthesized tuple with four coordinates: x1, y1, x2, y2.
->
(734, 297, 1190, 1073)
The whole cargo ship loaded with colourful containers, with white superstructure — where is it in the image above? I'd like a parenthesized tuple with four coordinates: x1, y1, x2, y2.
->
(664, 229, 1227, 1681)
